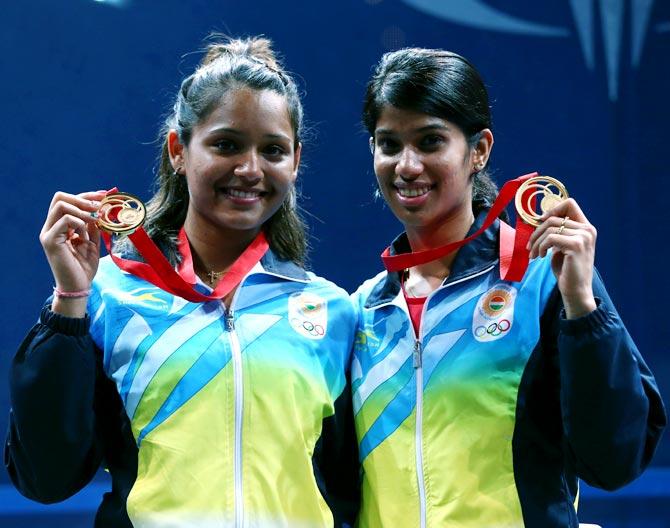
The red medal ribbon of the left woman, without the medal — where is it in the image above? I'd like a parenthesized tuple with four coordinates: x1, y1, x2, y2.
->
(102, 193, 270, 302)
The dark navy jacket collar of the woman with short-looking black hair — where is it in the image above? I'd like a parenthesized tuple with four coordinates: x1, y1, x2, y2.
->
(365, 209, 500, 308)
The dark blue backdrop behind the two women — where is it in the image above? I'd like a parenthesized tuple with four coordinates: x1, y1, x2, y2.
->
(0, 0, 670, 527)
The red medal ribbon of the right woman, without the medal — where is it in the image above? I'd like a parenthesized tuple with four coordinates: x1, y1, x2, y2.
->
(381, 172, 538, 282)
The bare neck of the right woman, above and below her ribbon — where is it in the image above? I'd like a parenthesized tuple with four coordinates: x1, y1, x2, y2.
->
(405, 208, 475, 283)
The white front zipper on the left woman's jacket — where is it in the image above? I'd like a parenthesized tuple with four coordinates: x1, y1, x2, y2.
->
(225, 310, 244, 528)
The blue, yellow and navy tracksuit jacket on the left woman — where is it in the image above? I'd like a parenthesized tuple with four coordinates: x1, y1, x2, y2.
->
(5, 251, 359, 528)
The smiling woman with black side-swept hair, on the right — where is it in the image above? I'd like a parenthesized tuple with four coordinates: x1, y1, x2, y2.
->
(352, 49, 666, 528)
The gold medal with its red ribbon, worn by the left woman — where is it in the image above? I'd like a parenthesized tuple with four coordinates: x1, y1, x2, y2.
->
(98, 188, 270, 302)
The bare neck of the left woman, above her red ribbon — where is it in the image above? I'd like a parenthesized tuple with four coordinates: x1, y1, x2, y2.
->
(184, 216, 259, 274)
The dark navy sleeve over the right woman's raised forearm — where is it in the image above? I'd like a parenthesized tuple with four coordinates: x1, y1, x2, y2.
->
(559, 299, 665, 489)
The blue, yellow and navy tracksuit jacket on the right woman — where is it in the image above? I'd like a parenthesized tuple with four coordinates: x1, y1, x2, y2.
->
(351, 211, 666, 528)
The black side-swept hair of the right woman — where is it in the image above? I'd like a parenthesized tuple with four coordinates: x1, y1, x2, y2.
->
(363, 48, 498, 216)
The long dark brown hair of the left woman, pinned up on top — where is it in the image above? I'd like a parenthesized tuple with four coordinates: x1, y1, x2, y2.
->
(145, 37, 307, 265)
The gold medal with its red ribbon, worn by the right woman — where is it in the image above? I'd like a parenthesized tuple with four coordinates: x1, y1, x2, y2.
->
(381, 172, 567, 282)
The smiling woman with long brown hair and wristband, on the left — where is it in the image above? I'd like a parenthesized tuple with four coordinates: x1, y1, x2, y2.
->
(6, 39, 359, 528)
